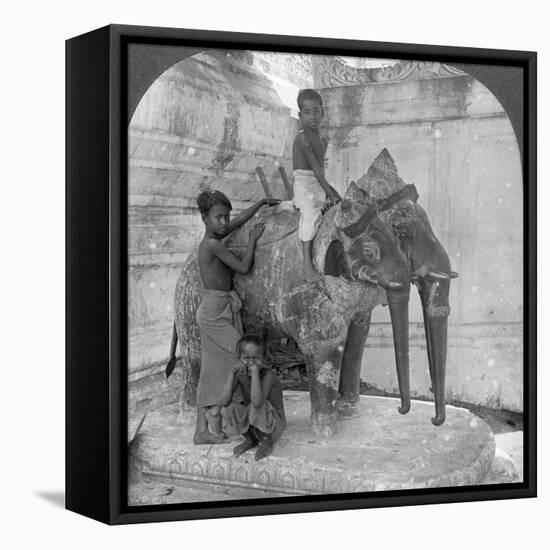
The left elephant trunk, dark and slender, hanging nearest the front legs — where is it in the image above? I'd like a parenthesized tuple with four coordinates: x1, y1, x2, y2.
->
(387, 286, 411, 414)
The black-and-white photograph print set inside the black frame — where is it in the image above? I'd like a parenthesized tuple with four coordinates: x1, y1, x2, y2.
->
(127, 44, 524, 507)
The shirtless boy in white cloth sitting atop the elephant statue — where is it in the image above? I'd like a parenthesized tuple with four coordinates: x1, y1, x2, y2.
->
(292, 88, 342, 281)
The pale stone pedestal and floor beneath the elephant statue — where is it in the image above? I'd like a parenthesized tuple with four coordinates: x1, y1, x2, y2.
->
(129, 391, 519, 505)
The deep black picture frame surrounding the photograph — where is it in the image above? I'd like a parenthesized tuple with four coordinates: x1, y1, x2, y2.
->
(66, 25, 537, 524)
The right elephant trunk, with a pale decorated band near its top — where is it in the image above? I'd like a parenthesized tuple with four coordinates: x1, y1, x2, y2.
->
(419, 281, 449, 426)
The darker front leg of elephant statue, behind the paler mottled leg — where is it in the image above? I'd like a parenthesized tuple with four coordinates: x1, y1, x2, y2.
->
(338, 311, 371, 418)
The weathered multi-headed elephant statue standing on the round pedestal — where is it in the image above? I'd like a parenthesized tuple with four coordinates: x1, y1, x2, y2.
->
(167, 149, 460, 435)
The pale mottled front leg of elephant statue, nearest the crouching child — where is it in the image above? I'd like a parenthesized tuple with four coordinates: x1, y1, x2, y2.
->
(301, 341, 344, 436)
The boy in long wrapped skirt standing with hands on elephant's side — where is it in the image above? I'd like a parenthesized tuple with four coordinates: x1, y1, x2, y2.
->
(193, 191, 279, 445)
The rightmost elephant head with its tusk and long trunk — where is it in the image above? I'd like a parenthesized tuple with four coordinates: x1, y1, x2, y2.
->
(384, 195, 458, 426)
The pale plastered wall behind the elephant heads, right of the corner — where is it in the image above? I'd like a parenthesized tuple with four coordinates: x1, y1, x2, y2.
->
(322, 75, 523, 411)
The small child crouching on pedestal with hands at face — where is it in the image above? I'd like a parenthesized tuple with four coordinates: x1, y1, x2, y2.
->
(220, 335, 286, 460)
